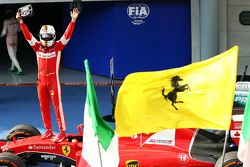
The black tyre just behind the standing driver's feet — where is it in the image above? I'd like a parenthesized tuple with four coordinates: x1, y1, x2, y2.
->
(6, 124, 41, 141)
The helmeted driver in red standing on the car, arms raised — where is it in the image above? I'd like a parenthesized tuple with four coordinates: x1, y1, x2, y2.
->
(16, 8, 80, 143)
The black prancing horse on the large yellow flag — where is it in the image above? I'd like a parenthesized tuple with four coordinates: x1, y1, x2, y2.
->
(161, 76, 189, 110)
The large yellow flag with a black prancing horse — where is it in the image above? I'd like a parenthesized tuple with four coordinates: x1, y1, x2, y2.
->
(115, 46, 238, 137)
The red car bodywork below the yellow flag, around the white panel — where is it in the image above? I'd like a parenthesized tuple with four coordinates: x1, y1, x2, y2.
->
(119, 129, 214, 167)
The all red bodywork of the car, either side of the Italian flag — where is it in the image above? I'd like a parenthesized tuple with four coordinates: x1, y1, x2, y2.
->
(0, 129, 214, 167)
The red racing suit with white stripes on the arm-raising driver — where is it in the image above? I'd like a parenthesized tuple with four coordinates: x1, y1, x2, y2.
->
(20, 21, 75, 132)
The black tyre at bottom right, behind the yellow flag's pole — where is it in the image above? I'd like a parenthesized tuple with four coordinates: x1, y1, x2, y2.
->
(214, 151, 243, 167)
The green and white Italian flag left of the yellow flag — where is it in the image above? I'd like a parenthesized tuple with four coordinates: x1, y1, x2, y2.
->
(78, 60, 119, 167)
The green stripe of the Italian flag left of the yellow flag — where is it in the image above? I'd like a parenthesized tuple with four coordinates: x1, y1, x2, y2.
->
(84, 60, 114, 151)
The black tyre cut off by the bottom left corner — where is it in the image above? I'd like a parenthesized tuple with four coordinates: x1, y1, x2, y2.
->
(0, 152, 26, 167)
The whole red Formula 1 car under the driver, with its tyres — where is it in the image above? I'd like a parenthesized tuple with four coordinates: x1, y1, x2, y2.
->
(0, 121, 242, 167)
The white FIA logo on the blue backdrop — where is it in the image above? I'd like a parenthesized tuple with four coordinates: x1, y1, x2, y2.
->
(127, 3, 150, 25)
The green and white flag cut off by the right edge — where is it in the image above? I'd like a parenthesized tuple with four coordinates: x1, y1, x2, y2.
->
(238, 89, 250, 167)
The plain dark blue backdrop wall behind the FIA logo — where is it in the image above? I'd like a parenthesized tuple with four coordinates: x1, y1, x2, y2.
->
(63, 0, 191, 79)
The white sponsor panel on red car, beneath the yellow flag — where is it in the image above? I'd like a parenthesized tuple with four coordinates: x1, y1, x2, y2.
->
(144, 129, 175, 146)
